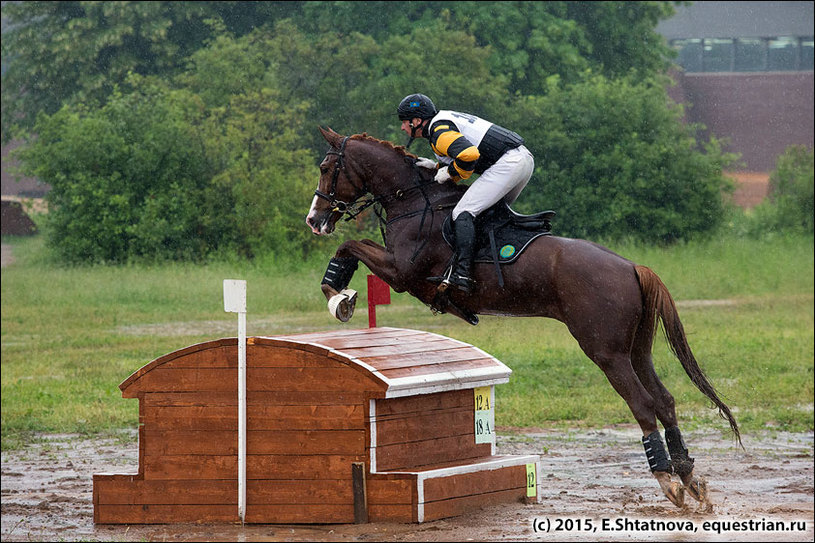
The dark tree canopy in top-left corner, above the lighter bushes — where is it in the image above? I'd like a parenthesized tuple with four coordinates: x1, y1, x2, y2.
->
(2, 1, 302, 142)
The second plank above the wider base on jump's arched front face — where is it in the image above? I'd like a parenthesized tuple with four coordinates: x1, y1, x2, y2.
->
(144, 429, 367, 456)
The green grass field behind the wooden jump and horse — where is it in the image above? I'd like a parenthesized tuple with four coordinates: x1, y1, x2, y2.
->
(1, 232, 813, 449)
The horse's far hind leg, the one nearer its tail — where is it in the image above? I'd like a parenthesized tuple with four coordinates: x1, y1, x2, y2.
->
(631, 329, 709, 504)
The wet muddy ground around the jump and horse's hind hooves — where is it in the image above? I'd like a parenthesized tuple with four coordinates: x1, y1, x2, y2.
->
(2, 426, 813, 541)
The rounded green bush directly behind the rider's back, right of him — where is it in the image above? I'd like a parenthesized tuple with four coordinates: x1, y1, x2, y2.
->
(515, 75, 732, 242)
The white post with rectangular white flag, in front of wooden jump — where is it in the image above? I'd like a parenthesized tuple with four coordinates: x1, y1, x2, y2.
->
(224, 279, 246, 523)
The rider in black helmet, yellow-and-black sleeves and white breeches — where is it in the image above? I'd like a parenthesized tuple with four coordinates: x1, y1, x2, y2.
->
(396, 94, 535, 292)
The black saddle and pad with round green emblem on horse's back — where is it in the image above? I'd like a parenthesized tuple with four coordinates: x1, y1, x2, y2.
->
(442, 202, 555, 264)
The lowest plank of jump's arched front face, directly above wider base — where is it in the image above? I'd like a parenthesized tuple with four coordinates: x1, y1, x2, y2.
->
(144, 454, 367, 481)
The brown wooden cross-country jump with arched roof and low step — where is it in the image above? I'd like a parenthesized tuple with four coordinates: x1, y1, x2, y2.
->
(93, 328, 539, 524)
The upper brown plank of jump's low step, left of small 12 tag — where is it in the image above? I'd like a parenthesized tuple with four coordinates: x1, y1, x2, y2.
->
(424, 465, 526, 502)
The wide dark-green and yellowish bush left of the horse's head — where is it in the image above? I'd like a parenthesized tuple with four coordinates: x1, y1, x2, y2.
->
(19, 77, 328, 263)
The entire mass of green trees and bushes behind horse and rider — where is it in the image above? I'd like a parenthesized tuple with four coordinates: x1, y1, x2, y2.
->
(3, 2, 728, 262)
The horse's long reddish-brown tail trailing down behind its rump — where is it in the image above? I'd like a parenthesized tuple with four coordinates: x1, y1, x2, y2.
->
(635, 266, 741, 445)
